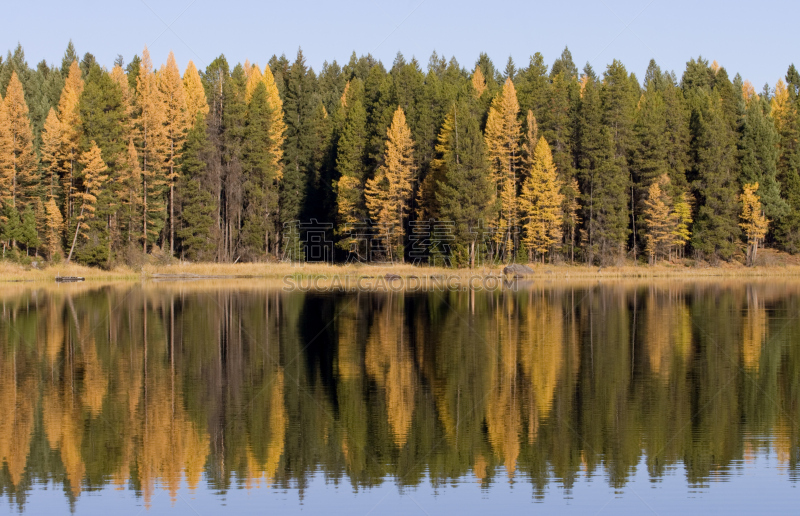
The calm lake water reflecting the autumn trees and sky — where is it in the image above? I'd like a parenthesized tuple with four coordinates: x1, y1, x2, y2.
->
(0, 280, 800, 515)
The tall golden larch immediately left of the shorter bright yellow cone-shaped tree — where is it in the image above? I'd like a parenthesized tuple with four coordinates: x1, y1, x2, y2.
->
(484, 79, 521, 258)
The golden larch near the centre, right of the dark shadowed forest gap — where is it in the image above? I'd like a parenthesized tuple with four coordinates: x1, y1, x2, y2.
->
(365, 107, 415, 259)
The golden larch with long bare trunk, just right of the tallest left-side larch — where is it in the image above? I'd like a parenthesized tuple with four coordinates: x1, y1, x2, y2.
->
(158, 52, 191, 256)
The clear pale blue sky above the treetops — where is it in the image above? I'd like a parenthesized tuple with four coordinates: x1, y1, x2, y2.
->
(0, 0, 800, 90)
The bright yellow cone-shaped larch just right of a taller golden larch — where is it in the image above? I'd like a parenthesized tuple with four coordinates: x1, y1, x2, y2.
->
(520, 137, 564, 262)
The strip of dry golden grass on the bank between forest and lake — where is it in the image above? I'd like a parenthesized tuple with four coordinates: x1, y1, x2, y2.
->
(0, 249, 800, 282)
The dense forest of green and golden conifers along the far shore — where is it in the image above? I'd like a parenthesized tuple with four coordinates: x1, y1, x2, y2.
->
(0, 42, 800, 267)
